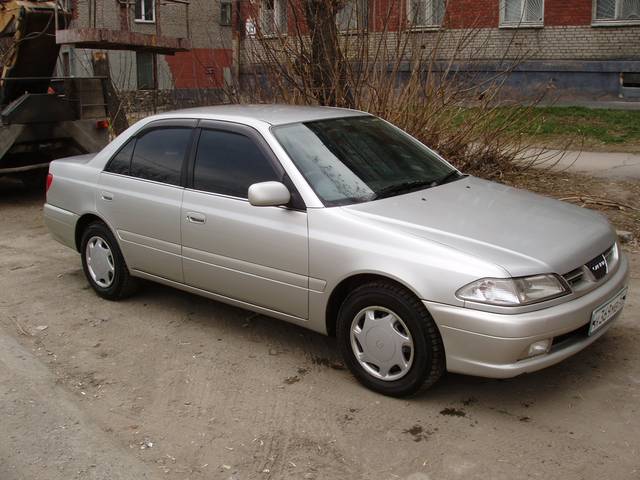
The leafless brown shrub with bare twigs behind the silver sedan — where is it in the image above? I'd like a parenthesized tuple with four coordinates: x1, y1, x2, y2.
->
(226, 0, 558, 178)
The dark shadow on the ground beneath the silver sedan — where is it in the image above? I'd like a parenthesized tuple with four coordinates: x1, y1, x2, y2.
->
(131, 283, 637, 408)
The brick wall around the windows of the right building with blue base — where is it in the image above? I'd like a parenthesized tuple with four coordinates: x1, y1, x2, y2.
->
(238, 0, 640, 98)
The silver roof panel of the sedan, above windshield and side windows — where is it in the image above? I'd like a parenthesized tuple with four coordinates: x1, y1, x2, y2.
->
(156, 104, 369, 125)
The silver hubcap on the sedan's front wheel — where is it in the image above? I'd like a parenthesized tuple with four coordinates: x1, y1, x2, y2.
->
(350, 307, 414, 381)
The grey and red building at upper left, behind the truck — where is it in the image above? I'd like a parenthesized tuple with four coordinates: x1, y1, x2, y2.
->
(57, 0, 232, 99)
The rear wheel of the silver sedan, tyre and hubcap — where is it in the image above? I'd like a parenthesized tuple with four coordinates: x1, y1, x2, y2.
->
(80, 222, 137, 300)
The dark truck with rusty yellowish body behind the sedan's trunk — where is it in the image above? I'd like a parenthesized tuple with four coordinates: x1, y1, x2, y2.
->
(0, 0, 109, 184)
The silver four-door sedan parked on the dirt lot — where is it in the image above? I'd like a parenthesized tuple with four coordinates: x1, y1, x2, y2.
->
(44, 105, 628, 396)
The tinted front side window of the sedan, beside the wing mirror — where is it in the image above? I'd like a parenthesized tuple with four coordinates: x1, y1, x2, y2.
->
(191, 130, 282, 198)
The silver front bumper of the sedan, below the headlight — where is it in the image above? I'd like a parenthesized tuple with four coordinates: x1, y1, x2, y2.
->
(424, 254, 629, 378)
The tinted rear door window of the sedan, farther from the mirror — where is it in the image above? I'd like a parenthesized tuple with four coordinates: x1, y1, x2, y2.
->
(129, 127, 193, 185)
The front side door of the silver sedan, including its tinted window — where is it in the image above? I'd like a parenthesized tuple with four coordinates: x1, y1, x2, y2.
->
(181, 121, 308, 319)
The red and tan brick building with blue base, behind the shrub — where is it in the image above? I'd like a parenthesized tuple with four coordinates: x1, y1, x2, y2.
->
(237, 0, 640, 99)
